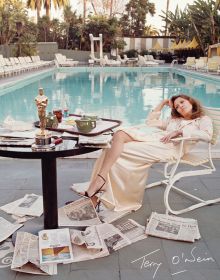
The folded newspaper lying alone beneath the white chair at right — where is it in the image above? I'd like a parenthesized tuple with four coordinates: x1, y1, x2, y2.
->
(145, 212, 201, 242)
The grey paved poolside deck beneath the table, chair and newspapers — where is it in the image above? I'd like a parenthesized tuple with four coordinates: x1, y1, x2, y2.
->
(0, 158, 220, 280)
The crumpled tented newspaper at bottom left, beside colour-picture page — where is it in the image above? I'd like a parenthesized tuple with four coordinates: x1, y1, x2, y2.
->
(11, 232, 57, 275)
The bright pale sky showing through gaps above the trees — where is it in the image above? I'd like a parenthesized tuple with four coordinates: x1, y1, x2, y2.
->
(30, 0, 194, 30)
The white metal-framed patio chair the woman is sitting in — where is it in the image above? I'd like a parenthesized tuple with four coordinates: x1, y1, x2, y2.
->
(146, 108, 220, 215)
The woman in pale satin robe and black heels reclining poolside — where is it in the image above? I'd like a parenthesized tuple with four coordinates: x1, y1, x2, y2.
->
(74, 94, 213, 211)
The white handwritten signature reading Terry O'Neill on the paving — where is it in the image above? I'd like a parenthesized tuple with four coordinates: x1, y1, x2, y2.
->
(131, 246, 215, 279)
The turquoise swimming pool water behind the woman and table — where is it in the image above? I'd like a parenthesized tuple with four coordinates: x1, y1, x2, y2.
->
(0, 68, 220, 125)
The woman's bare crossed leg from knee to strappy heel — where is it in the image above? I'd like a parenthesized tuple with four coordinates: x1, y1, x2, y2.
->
(87, 130, 134, 196)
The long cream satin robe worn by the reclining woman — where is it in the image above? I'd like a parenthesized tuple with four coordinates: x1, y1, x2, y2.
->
(91, 112, 213, 211)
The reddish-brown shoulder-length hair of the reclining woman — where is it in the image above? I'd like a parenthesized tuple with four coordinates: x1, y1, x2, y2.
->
(170, 94, 205, 120)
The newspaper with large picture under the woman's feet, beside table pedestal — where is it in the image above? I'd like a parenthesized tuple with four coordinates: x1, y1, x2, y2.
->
(58, 198, 101, 227)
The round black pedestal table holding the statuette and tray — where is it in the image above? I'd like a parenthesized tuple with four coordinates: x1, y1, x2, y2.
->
(0, 140, 98, 229)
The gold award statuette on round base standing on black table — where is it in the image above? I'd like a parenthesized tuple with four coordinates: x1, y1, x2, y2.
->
(32, 88, 55, 150)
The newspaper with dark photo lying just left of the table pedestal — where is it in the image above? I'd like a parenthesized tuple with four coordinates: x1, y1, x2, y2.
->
(0, 193, 43, 217)
